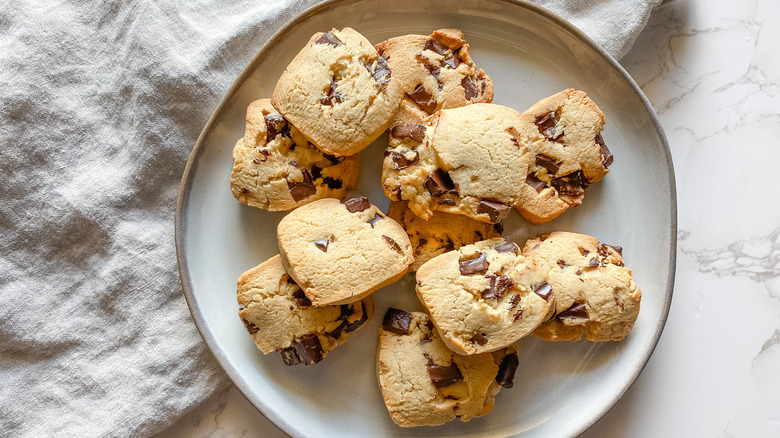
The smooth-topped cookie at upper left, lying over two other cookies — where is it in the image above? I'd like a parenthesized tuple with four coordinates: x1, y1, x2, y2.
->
(271, 27, 403, 156)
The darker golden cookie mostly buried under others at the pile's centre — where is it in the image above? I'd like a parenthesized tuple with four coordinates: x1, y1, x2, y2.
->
(387, 202, 504, 271)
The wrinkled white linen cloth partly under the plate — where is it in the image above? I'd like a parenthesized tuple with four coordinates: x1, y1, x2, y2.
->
(0, 0, 660, 437)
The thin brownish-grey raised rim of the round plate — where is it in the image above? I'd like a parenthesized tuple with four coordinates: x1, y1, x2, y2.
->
(174, 0, 677, 436)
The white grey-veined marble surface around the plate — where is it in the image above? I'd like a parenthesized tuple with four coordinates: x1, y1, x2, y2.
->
(157, 0, 780, 438)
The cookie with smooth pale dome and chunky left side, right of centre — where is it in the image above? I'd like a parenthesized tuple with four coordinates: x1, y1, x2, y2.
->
(382, 103, 528, 223)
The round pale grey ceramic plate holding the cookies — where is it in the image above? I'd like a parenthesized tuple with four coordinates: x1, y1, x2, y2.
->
(176, 0, 676, 437)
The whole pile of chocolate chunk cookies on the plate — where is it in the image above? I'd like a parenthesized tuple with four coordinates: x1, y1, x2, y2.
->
(231, 28, 641, 427)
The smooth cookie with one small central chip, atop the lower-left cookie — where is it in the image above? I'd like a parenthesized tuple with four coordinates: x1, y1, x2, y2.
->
(277, 196, 414, 306)
